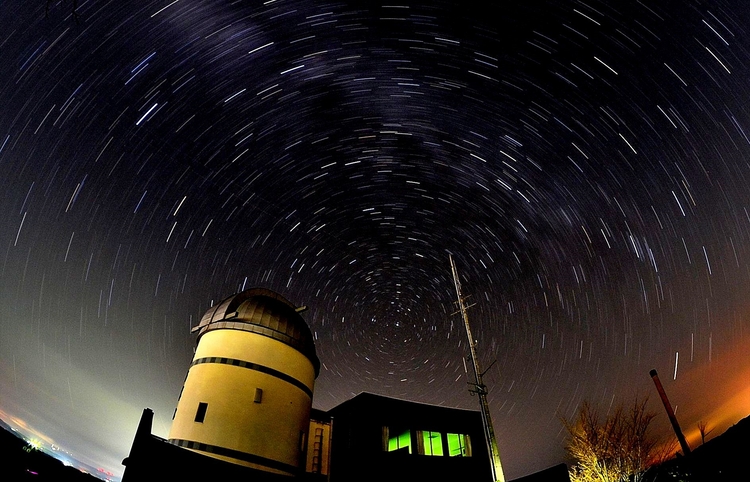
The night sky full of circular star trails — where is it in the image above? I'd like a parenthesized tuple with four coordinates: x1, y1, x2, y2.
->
(0, 0, 750, 478)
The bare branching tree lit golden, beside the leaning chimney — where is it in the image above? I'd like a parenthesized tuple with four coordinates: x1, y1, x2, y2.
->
(563, 399, 661, 482)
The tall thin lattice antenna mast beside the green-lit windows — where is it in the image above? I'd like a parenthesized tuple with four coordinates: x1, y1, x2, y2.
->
(448, 254, 505, 482)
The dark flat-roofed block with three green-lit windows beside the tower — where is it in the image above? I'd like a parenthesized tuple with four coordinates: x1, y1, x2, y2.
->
(320, 393, 491, 482)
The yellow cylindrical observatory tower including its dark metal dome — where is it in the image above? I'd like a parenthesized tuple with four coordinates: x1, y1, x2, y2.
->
(169, 288, 320, 475)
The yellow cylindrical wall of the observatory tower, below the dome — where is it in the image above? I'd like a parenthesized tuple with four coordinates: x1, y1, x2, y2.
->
(169, 329, 315, 474)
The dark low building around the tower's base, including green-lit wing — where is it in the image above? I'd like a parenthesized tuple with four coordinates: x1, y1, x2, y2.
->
(123, 393, 491, 482)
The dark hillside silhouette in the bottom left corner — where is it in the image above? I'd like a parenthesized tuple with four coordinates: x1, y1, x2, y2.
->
(0, 420, 106, 482)
